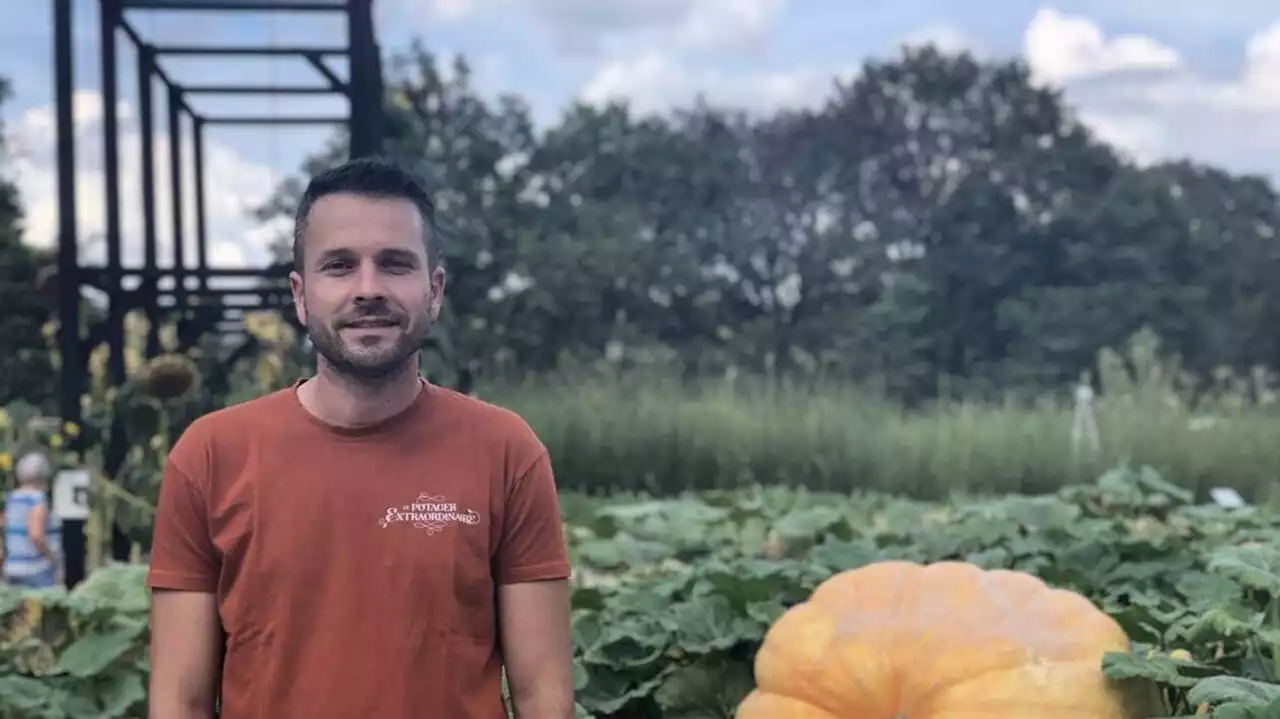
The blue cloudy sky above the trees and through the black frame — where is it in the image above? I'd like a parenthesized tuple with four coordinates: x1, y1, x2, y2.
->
(0, 0, 1280, 267)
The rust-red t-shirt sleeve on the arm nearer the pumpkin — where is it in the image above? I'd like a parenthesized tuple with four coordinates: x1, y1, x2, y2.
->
(494, 450, 570, 585)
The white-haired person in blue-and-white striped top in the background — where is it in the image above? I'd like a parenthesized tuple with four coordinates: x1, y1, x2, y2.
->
(4, 452, 63, 587)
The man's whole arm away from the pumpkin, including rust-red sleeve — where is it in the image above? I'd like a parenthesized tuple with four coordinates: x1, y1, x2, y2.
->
(147, 455, 224, 719)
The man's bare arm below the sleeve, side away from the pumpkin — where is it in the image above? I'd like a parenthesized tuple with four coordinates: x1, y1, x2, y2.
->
(150, 590, 223, 719)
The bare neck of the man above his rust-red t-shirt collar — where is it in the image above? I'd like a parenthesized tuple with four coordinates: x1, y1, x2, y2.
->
(298, 360, 422, 427)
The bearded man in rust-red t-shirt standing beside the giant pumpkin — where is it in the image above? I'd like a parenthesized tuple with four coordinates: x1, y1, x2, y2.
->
(148, 160, 573, 719)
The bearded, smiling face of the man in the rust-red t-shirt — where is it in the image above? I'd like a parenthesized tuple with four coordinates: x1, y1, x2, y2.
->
(289, 194, 444, 379)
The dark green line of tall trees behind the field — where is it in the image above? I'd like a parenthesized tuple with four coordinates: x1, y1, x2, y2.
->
(0, 43, 1280, 402)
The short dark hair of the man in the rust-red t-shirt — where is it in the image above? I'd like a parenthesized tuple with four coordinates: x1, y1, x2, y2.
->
(293, 157, 440, 273)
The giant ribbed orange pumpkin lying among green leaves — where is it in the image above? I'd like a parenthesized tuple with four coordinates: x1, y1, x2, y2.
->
(736, 562, 1162, 719)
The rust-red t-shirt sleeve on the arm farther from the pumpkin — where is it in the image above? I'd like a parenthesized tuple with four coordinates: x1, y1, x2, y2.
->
(147, 459, 221, 592)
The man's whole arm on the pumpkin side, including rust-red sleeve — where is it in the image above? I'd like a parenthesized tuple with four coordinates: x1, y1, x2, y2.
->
(497, 450, 573, 719)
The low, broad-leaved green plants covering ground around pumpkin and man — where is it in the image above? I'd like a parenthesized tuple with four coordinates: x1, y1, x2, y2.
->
(0, 467, 1280, 719)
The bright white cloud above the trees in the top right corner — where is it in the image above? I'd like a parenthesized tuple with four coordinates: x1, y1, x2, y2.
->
(1024, 8, 1280, 177)
